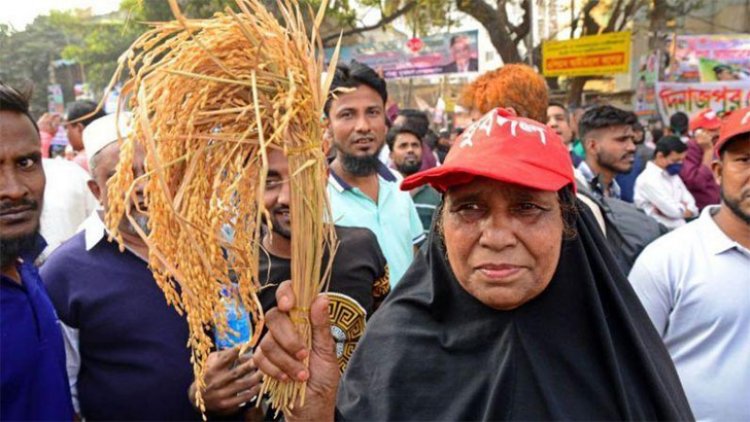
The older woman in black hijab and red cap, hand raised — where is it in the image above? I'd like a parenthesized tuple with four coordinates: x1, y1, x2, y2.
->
(255, 109, 692, 421)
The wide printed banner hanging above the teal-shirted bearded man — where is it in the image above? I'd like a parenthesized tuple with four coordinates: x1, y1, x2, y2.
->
(325, 31, 479, 79)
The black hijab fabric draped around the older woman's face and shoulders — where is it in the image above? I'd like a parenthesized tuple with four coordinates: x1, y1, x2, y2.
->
(337, 199, 693, 421)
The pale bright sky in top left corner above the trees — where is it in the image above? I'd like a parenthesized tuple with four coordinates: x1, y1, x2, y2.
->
(0, 0, 120, 31)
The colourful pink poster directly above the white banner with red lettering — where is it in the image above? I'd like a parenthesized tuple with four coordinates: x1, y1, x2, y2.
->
(665, 34, 750, 82)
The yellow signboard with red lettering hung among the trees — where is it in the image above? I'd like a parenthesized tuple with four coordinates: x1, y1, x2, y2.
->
(542, 31, 630, 76)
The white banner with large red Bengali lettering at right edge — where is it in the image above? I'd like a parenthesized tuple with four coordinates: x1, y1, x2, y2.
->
(656, 81, 750, 123)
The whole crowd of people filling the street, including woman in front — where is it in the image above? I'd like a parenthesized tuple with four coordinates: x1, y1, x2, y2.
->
(0, 56, 750, 421)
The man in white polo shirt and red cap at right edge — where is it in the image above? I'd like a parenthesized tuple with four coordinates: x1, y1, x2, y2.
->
(629, 107, 750, 421)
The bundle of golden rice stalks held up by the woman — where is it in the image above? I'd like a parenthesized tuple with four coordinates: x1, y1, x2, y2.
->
(106, 0, 336, 416)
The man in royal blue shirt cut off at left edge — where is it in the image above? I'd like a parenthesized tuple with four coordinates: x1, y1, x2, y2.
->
(0, 84, 73, 420)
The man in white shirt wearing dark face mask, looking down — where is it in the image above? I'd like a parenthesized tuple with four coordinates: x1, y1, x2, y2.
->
(634, 136, 698, 229)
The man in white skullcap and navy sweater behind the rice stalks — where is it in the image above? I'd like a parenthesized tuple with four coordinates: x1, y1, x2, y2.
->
(41, 114, 200, 420)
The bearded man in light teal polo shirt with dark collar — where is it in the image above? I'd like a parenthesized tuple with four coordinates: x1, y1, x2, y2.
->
(324, 61, 425, 286)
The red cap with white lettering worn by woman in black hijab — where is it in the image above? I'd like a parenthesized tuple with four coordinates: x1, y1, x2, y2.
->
(401, 108, 575, 192)
